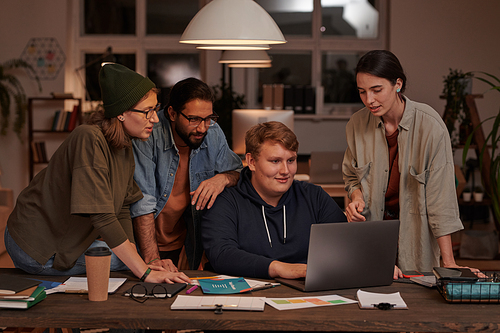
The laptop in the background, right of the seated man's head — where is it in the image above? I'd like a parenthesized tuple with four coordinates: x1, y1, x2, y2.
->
(309, 151, 344, 184)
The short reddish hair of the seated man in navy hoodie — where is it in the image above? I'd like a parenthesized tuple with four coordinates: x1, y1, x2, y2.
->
(245, 121, 299, 159)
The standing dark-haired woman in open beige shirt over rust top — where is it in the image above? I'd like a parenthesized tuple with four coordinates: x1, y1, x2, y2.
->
(342, 50, 480, 279)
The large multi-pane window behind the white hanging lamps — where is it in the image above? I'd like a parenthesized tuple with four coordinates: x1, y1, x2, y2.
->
(65, 0, 388, 114)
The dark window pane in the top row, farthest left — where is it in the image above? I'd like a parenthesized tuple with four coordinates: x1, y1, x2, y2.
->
(84, 0, 135, 35)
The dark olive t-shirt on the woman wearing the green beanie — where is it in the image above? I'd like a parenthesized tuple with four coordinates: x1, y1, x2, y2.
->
(8, 125, 142, 270)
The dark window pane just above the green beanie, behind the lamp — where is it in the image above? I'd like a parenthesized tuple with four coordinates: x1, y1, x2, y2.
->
(83, 53, 135, 101)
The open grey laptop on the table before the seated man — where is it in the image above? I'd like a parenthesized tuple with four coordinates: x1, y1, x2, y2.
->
(276, 220, 399, 291)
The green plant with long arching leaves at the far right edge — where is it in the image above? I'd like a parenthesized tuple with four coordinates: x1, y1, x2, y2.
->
(462, 72, 500, 230)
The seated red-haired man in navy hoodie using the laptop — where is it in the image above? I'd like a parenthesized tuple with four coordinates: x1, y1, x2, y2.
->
(201, 121, 347, 279)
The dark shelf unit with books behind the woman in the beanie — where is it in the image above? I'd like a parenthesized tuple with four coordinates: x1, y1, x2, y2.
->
(28, 97, 82, 181)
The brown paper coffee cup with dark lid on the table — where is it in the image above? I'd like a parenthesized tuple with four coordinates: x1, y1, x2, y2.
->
(85, 247, 111, 301)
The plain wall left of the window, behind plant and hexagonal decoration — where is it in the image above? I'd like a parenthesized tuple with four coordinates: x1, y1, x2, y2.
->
(0, 0, 66, 198)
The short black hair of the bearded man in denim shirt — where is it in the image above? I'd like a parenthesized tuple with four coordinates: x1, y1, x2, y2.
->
(166, 77, 214, 113)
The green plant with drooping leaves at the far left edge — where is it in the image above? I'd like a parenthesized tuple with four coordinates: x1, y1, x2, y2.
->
(0, 59, 42, 141)
